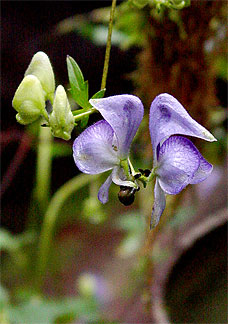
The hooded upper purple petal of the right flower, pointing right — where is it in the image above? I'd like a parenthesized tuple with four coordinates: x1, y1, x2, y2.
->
(149, 93, 216, 162)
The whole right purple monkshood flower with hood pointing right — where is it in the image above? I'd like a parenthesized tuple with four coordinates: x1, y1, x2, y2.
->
(149, 93, 216, 228)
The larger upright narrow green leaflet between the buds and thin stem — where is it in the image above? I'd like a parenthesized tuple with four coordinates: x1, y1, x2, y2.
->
(67, 55, 91, 108)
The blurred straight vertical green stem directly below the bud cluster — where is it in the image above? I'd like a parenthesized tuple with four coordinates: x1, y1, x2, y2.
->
(35, 127, 53, 213)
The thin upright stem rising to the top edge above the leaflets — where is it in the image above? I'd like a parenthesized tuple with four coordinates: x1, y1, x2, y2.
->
(101, 0, 116, 89)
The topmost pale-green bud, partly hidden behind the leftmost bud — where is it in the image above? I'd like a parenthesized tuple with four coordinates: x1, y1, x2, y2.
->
(25, 52, 55, 102)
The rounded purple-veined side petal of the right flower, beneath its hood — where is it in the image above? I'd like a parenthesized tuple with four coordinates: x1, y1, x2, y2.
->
(156, 136, 200, 195)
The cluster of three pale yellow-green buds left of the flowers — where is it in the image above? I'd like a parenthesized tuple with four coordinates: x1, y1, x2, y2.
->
(12, 52, 74, 140)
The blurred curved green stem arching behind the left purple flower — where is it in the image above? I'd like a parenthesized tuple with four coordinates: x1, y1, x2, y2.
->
(37, 174, 99, 290)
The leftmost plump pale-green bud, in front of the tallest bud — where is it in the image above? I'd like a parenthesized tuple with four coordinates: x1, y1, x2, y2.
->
(12, 75, 45, 125)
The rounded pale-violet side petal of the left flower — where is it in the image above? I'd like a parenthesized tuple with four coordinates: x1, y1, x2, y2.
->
(73, 120, 119, 174)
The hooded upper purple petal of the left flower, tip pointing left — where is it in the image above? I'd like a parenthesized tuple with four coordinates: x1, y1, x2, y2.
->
(89, 94, 144, 159)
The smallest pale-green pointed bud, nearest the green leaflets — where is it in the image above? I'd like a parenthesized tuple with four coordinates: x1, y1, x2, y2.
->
(49, 85, 74, 140)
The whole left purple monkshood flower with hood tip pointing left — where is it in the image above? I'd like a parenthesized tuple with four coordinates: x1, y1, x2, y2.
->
(73, 94, 144, 204)
